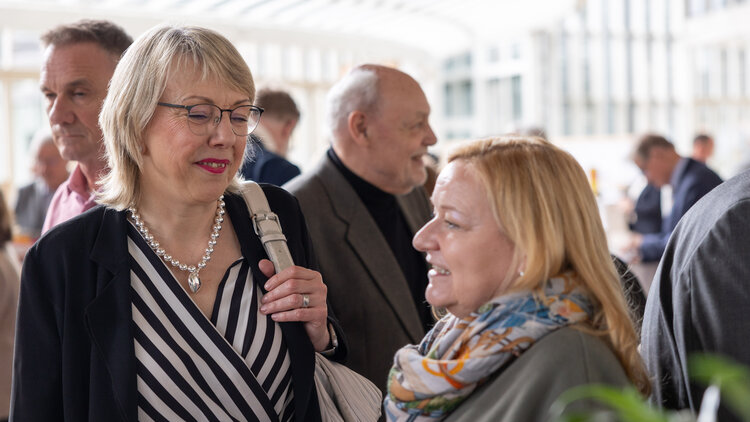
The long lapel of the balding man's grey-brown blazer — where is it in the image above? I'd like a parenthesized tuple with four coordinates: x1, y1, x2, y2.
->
(316, 157, 424, 343)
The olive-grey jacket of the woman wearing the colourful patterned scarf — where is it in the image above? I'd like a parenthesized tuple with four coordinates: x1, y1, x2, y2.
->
(445, 328, 630, 422)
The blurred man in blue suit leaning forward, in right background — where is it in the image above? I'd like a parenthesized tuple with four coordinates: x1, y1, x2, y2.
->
(630, 134, 722, 262)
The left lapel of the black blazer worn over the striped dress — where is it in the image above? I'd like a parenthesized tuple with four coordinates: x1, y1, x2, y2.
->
(84, 208, 138, 421)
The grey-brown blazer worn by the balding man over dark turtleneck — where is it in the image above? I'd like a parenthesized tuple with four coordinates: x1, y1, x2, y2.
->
(284, 156, 431, 391)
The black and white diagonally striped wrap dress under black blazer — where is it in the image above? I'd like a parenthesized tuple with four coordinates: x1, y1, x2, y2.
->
(128, 225, 294, 421)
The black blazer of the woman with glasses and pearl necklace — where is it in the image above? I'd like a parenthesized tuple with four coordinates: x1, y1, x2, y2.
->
(10, 185, 346, 422)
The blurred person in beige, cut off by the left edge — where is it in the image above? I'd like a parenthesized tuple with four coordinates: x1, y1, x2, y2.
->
(0, 191, 18, 421)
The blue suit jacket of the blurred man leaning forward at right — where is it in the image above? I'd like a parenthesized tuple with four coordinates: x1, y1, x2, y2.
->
(641, 158, 722, 262)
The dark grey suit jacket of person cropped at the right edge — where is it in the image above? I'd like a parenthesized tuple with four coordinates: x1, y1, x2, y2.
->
(642, 172, 750, 421)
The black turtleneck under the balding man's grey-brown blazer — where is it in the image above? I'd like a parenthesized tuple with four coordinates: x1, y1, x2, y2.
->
(328, 149, 434, 331)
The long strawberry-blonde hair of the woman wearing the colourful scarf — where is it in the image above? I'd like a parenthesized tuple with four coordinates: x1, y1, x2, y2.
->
(448, 136, 650, 395)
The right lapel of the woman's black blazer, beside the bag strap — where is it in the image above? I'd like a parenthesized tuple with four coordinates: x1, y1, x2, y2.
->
(225, 194, 315, 422)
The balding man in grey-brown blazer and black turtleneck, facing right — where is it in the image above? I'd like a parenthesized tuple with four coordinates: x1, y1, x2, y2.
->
(284, 65, 436, 391)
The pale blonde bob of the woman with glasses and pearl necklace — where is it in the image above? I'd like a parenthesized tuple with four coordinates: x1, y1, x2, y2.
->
(97, 26, 255, 210)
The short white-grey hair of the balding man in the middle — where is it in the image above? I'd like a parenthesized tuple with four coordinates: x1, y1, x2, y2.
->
(326, 65, 379, 141)
